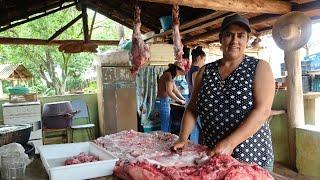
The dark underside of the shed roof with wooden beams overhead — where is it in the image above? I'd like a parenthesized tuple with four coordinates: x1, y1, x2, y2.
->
(0, 0, 320, 46)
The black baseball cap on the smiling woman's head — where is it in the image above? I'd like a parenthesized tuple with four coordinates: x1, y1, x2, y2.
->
(220, 14, 251, 34)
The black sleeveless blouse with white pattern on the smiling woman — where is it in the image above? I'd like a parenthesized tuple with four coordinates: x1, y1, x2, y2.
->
(197, 56, 273, 167)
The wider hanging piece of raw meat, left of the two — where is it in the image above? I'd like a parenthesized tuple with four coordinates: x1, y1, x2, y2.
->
(130, 5, 150, 75)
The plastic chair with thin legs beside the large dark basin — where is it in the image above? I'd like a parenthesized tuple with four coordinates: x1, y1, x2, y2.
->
(70, 100, 95, 142)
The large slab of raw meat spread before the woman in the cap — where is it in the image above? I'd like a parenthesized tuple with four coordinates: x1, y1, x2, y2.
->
(94, 130, 273, 180)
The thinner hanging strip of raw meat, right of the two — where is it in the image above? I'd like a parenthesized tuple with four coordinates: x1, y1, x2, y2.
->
(172, 5, 183, 61)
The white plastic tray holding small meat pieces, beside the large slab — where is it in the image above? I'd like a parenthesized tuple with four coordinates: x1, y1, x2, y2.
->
(39, 142, 118, 180)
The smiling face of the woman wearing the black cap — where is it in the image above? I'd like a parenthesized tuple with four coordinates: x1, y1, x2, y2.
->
(221, 24, 248, 59)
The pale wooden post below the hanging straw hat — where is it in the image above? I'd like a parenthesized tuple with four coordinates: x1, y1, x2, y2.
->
(285, 50, 304, 169)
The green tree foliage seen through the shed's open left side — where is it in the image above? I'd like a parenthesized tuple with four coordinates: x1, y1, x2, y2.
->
(0, 8, 131, 95)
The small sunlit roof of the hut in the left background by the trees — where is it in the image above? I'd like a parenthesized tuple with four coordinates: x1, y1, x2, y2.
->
(0, 64, 33, 80)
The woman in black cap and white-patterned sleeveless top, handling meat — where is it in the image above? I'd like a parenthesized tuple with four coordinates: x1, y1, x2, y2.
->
(173, 14, 275, 171)
